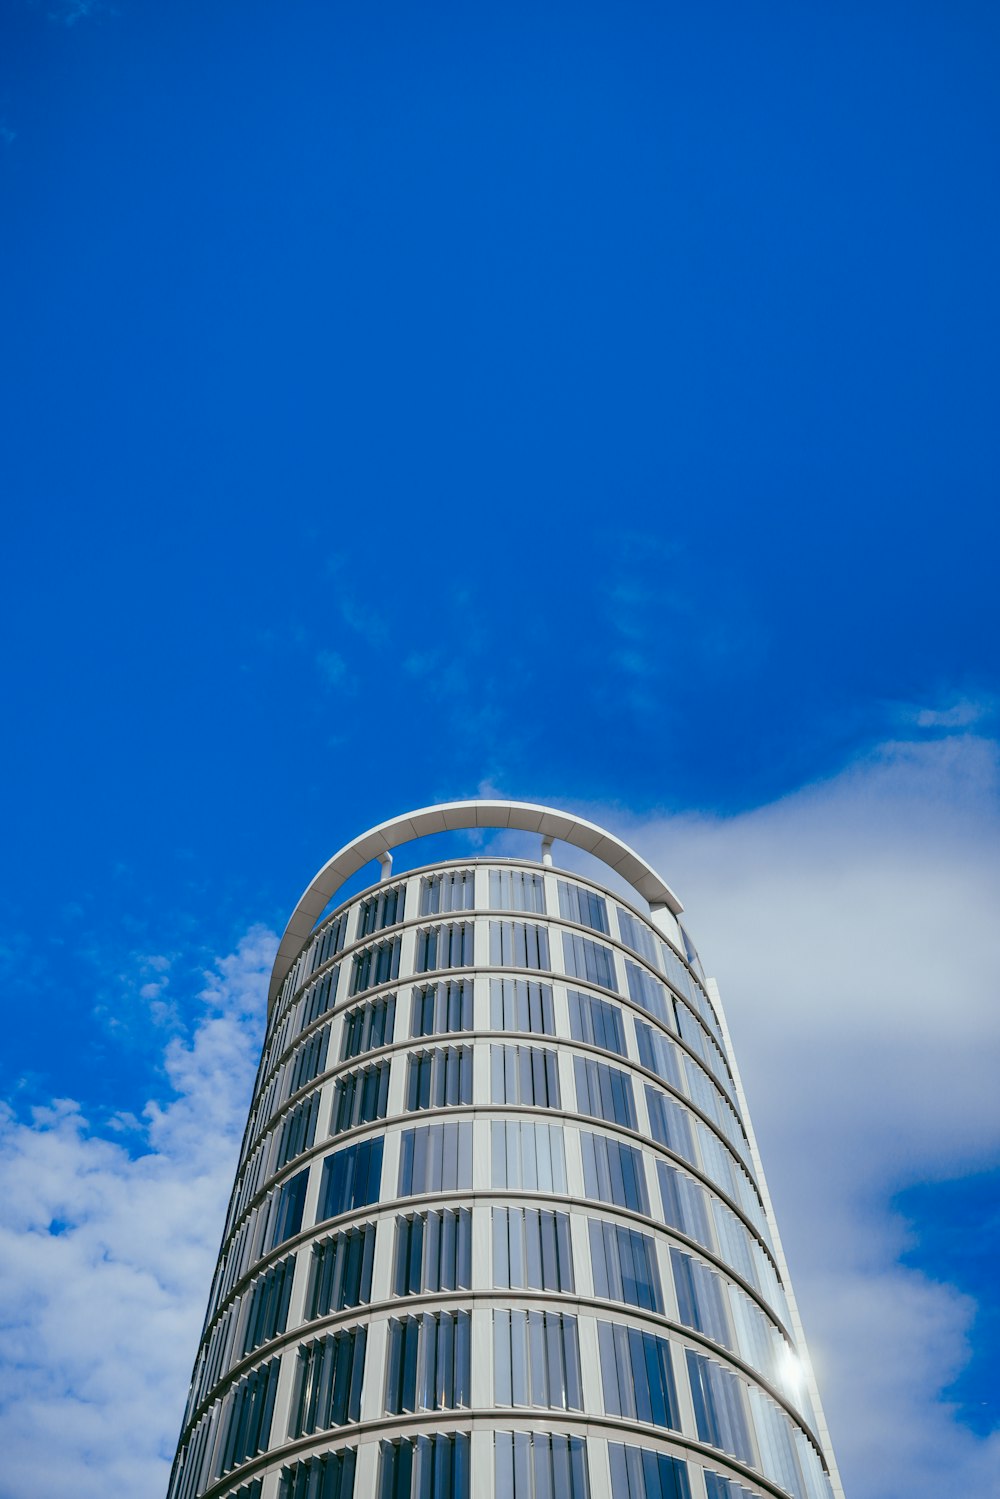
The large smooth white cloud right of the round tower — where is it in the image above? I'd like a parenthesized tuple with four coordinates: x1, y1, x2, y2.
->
(626, 735, 1000, 1499)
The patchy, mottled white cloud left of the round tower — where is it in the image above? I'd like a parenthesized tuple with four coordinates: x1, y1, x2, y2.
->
(0, 929, 276, 1499)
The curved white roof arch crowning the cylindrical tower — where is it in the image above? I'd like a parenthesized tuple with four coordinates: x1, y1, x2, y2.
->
(267, 800, 684, 1010)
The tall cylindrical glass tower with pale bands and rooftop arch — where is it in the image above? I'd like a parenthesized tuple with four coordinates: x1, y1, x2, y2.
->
(169, 802, 843, 1499)
